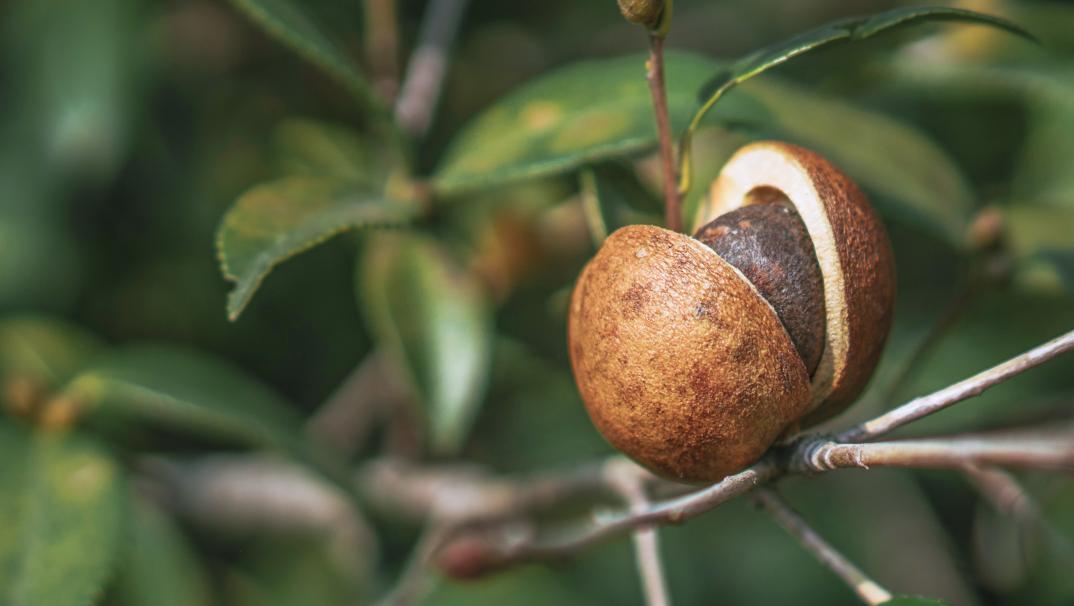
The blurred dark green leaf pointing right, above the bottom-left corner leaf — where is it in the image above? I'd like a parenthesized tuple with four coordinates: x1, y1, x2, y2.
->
(48, 345, 353, 505)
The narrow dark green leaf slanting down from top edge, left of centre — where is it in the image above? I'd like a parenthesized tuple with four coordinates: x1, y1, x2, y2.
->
(231, 0, 380, 107)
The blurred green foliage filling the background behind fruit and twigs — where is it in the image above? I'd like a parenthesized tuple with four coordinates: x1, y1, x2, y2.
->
(0, 0, 1074, 606)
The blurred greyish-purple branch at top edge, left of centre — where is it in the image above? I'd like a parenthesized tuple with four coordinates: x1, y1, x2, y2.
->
(395, 0, 468, 138)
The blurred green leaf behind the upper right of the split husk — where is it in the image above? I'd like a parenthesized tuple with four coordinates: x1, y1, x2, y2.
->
(743, 78, 975, 244)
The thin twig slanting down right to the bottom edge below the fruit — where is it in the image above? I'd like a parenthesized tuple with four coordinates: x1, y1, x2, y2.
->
(754, 488, 891, 606)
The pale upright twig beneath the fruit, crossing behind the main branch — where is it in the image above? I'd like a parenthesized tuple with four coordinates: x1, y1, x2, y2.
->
(605, 459, 671, 606)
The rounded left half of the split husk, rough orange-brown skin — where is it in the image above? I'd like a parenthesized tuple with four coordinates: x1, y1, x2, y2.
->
(568, 226, 810, 482)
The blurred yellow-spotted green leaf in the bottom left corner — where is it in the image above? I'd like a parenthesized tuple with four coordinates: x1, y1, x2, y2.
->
(0, 425, 126, 606)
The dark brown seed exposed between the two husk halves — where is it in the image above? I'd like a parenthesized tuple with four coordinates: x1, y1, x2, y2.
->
(694, 196, 826, 376)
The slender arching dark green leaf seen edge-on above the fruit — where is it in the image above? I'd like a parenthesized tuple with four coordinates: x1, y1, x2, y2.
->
(680, 6, 1035, 191)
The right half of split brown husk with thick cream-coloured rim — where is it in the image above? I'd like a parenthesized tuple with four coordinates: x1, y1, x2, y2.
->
(695, 141, 895, 427)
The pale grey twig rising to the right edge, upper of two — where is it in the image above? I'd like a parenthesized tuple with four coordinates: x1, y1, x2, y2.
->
(836, 331, 1074, 442)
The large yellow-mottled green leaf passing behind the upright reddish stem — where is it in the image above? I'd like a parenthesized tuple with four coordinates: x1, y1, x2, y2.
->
(433, 53, 763, 194)
